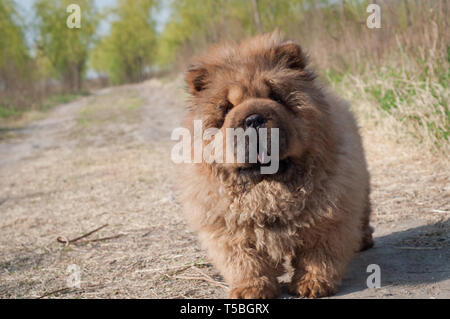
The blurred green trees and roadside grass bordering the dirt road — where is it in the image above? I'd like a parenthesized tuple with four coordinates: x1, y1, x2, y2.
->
(0, 0, 450, 155)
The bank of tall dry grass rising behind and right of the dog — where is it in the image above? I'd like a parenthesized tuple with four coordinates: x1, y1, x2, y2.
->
(163, 0, 450, 156)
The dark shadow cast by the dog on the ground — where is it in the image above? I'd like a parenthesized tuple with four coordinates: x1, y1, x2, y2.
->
(281, 221, 450, 298)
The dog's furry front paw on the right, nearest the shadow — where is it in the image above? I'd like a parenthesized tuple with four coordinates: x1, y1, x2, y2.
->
(289, 274, 337, 298)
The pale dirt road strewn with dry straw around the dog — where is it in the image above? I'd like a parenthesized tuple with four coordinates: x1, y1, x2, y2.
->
(0, 80, 450, 298)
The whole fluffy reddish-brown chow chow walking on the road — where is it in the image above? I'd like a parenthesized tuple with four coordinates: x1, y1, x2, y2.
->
(181, 33, 373, 298)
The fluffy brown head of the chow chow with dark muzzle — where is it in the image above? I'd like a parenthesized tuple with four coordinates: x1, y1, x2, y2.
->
(186, 33, 326, 181)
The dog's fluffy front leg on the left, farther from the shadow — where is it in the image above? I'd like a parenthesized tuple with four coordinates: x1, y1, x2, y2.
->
(204, 234, 279, 299)
